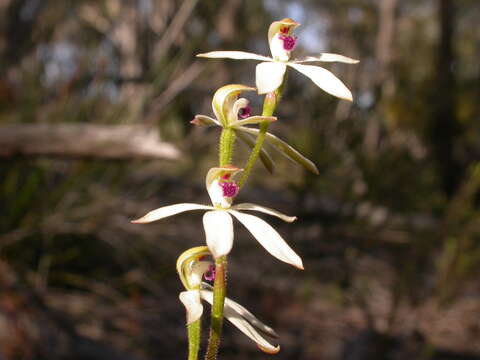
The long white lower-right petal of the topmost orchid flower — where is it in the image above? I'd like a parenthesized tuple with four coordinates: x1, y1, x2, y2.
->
(288, 63, 352, 101)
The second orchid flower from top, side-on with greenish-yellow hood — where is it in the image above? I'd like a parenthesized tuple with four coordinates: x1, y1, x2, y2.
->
(191, 84, 318, 174)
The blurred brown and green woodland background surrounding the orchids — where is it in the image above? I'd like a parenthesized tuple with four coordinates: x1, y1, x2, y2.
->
(0, 0, 480, 360)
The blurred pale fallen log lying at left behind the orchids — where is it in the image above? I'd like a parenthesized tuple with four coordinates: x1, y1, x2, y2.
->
(0, 124, 180, 160)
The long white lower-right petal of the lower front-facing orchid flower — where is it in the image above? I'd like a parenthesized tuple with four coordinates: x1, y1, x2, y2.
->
(228, 210, 303, 270)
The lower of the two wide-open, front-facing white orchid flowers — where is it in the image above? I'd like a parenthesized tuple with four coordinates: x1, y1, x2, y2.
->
(132, 167, 303, 270)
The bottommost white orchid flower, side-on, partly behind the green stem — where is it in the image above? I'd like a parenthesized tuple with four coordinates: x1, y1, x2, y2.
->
(177, 246, 280, 354)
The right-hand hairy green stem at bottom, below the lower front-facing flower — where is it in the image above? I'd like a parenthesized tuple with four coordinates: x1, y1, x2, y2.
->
(205, 256, 227, 360)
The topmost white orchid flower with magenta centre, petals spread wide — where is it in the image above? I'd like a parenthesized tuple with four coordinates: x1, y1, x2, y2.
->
(197, 18, 358, 101)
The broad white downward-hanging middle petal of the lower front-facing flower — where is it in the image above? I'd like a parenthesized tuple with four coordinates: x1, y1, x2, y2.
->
(203, 210, 233, 258)
